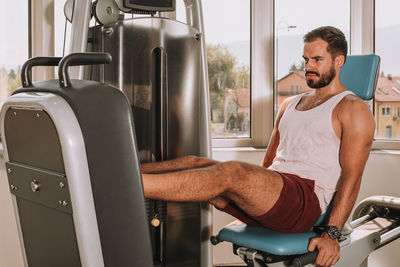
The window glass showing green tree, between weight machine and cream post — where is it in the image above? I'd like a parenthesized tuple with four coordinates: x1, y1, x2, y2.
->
(176, 0, 251, 138)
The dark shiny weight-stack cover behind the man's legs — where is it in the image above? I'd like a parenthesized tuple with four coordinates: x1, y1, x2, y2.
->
(91, 18, 206, 267)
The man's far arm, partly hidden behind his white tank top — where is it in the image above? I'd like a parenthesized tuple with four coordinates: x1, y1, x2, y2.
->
(261, 97, 294, 168)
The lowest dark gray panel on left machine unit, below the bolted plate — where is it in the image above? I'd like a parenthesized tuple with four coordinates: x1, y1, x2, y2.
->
(17, 198, 81, 267)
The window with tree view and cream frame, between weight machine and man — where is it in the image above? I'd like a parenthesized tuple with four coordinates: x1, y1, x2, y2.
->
(176, 0, 274, 147)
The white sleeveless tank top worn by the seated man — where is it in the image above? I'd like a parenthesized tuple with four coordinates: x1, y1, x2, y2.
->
(269, 91, 353, 213)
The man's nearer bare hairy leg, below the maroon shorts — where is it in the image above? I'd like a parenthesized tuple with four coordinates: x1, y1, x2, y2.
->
(142, 161, 283, 216)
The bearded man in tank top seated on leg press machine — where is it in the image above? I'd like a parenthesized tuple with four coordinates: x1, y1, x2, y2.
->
(142, 27, 375, 266)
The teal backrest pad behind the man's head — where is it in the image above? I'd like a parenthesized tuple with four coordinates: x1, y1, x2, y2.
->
(339, 55, 380, 100)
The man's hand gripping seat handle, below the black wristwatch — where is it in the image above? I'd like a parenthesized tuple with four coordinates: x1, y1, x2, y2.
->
(308, 233, 340, 266)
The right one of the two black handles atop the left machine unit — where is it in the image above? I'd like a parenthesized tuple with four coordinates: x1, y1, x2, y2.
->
(58, 53, 112, 88)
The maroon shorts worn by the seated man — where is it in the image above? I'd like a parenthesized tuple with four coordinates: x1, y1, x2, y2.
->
(217, 173, 321, 233)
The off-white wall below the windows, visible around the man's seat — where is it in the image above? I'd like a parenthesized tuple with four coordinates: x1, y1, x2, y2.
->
(213, 149, 400, 267)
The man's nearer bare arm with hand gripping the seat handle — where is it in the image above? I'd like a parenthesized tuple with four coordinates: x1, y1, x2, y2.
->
(309, 97, 375, 266)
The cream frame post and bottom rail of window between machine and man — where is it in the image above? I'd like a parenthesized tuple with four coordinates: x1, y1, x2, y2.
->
(212, 0, 275, 148)
